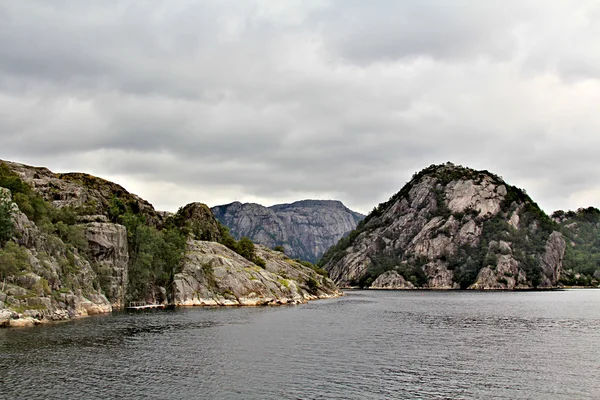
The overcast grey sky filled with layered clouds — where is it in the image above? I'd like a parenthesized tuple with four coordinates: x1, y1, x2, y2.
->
(0, 0, 600, 213)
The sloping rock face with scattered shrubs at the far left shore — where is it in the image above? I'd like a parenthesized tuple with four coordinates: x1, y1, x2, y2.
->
(0, 188, 112, 326)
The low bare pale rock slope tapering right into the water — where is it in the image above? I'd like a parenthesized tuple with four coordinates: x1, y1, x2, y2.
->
(174, 240, 341, 306)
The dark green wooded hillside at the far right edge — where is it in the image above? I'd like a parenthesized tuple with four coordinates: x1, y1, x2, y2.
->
(552, 207, 600, 286)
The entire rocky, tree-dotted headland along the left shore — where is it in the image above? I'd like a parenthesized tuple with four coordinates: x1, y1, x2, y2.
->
(0, 160, 341, 326)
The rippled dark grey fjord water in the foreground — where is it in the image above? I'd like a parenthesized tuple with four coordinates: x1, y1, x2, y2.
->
(0, 290, 600, 399)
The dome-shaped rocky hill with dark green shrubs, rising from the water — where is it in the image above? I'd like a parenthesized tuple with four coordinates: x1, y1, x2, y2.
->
(319, 163, 566, 289)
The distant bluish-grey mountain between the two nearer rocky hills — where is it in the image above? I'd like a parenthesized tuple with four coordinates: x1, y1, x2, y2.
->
(211, 200, 364, 263)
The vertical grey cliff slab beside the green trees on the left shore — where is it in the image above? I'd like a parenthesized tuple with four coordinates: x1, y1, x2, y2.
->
(85, 222, 129, 308)
